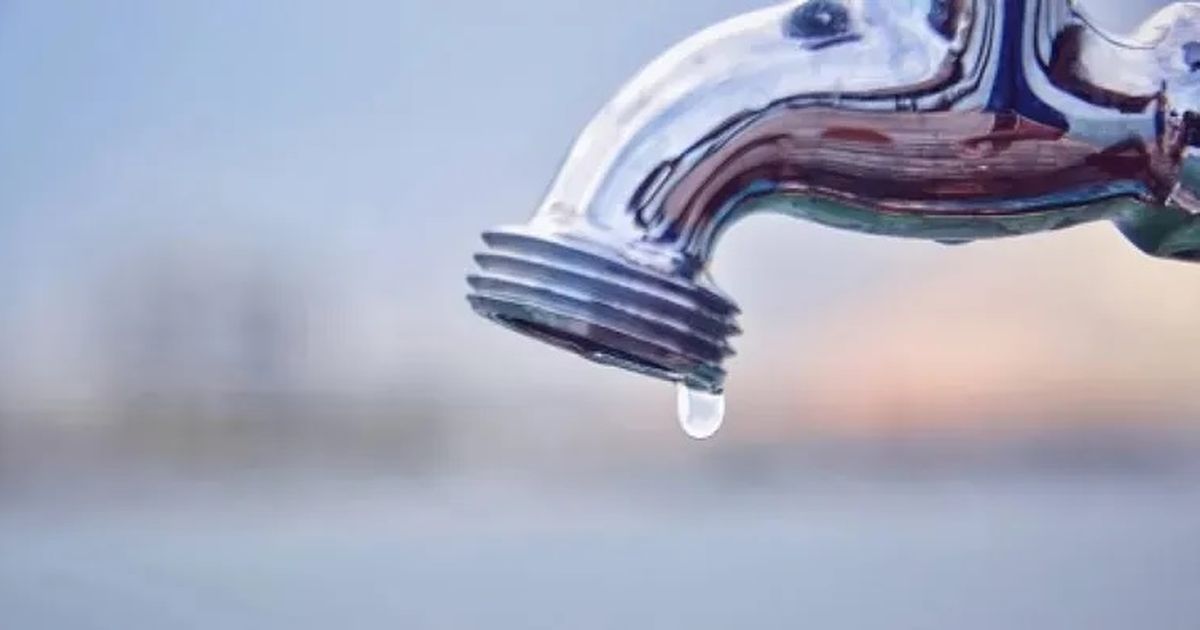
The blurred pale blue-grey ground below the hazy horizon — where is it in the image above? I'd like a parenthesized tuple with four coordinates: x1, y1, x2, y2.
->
(0, 468, 1200, 630)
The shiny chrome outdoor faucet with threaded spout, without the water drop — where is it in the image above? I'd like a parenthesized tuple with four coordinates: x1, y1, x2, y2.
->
(468, 0, 1200, 394)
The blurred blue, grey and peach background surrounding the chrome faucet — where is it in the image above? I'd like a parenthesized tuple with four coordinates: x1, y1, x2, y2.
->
(0, 0, 1200, 630)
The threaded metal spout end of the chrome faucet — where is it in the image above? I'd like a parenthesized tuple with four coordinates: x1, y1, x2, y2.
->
(467, 227, 740, 392)
